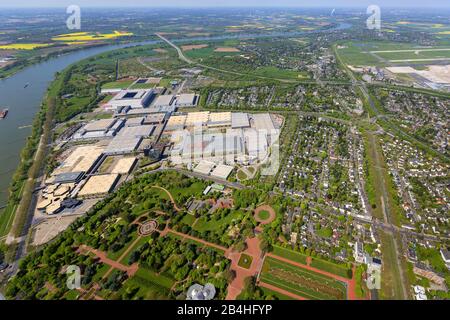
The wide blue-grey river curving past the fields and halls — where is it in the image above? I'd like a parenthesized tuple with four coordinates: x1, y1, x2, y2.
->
(0, 23, 351, 207)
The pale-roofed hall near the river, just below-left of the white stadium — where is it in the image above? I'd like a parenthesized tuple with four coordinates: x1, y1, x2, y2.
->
(72, 119, 124, 140)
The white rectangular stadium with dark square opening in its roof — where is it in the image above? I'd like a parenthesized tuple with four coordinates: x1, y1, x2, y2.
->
(105, 89, 156, 110)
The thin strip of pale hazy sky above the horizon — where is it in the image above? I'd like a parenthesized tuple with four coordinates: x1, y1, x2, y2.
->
(0, 0, 450, 8)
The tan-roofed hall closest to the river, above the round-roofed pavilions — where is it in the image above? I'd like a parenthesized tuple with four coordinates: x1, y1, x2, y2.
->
(53, 145, 104, 176)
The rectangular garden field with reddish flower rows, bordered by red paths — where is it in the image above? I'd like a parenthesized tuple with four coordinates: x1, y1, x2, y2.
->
(260, 257, 347, 300)
